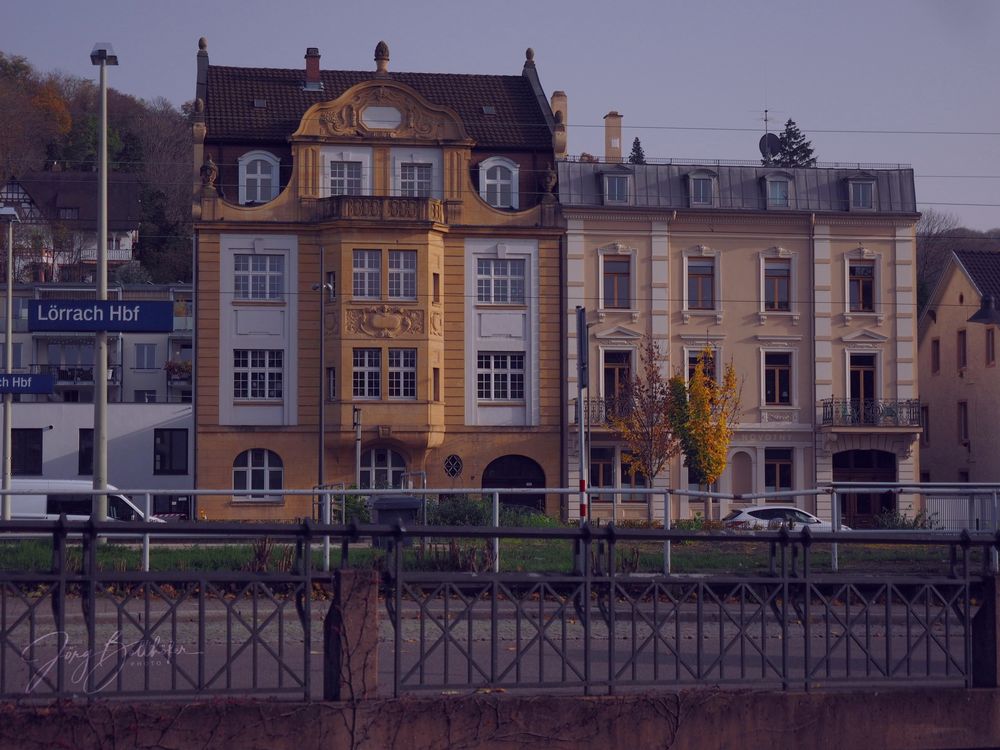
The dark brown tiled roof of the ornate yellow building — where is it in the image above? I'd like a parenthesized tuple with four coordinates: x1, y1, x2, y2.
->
(205, 65, 552, 150)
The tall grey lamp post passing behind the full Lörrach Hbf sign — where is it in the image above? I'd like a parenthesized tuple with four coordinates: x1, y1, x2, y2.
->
(90, 42, 118, 521)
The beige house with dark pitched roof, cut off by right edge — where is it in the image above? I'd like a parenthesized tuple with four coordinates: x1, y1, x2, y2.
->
(920, 250, 1000, 482)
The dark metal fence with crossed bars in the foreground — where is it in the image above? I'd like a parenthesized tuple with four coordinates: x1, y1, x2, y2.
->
(0, 521, 998, 700)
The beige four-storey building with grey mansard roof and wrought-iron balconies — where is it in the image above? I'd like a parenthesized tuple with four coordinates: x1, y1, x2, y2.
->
(559, 113, 920, 527)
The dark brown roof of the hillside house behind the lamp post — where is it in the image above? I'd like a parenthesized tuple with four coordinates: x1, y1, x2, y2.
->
(17, 172, 140, 231)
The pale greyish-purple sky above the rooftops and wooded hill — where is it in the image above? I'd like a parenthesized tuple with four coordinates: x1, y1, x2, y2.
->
(0, 0, 1000, 229)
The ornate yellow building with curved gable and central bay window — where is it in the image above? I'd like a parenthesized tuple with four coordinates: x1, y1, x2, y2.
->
(188, 40, 565, 518)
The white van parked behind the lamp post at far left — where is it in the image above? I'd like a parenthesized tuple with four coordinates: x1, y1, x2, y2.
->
(2, 477, 163, 523)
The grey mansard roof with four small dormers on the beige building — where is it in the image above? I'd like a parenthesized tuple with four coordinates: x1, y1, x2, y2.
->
(559, 161, 917, 214)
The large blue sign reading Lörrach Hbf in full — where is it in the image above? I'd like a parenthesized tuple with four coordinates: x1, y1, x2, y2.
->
(28, 299, 174, 333)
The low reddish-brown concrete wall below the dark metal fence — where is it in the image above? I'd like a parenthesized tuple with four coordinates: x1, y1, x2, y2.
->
(0, 689, 1000, 750)
